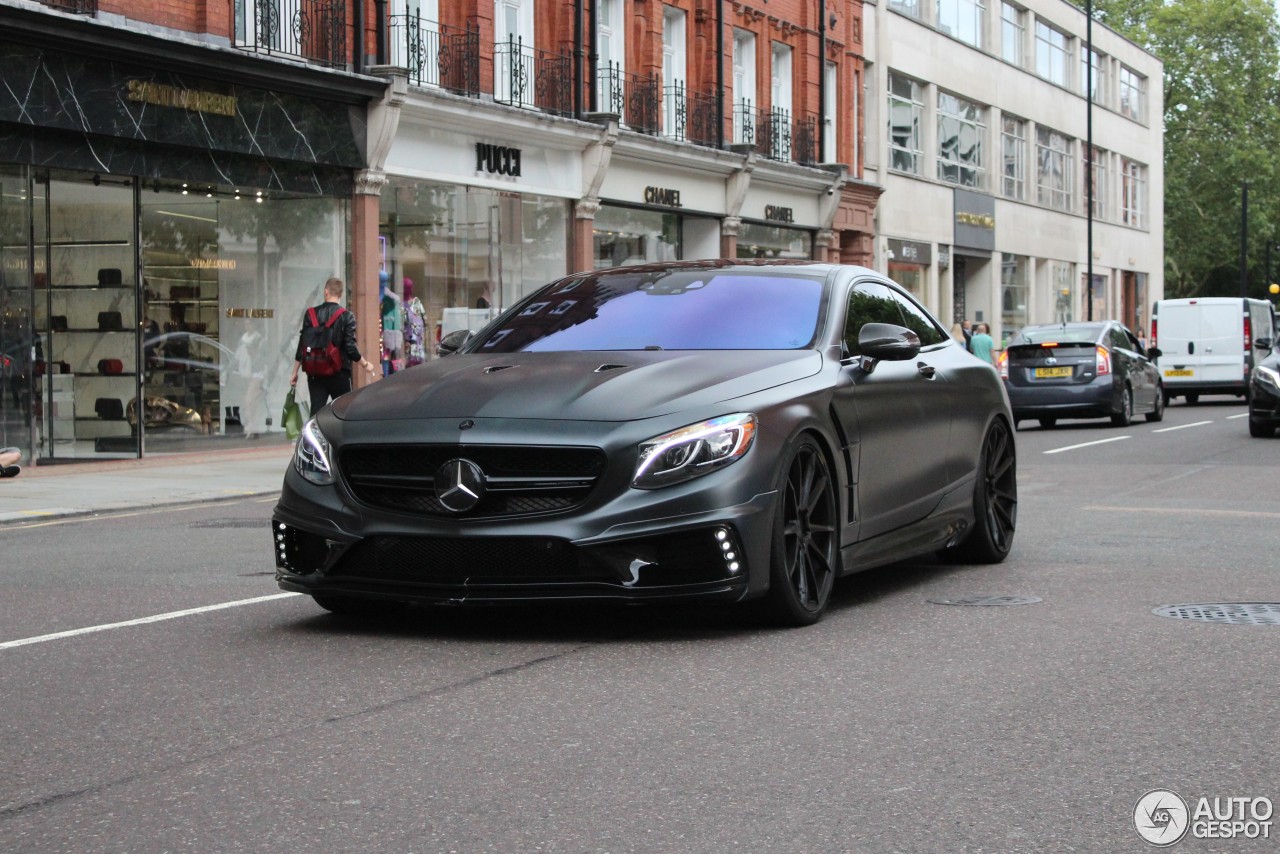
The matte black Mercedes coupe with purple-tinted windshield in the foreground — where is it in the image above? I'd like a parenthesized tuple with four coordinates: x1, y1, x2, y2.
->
(273, 261, 1018, 625)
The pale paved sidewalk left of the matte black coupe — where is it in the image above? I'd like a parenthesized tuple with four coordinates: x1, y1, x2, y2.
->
(0, 443, 293, 526)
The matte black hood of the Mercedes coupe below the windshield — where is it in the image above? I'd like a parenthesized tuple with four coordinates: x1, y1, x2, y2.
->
(333, 350, 822, 421)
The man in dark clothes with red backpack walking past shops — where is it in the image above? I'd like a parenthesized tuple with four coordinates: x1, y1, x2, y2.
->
(289, 277, 374, 415)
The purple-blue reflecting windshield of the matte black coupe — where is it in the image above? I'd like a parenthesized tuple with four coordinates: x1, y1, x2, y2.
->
(467, 270, 823, 353)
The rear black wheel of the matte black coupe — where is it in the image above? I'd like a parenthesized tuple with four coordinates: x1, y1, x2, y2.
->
(941, 421, 1018, 563)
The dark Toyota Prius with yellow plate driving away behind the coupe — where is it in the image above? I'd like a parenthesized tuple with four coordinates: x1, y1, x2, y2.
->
(1000, 320, 1167, 428)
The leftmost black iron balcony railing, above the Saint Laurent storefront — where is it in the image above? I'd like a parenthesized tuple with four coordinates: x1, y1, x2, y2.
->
(233, 0, 348, 67)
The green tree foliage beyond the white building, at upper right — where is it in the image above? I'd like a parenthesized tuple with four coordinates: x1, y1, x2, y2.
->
(1078, 0, 1280, 297)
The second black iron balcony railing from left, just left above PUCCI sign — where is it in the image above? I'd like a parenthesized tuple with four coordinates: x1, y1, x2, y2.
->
(389, 12, 480, 95)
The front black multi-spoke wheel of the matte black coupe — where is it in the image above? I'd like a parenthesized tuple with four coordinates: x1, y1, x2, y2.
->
(767, 437, 840, 626)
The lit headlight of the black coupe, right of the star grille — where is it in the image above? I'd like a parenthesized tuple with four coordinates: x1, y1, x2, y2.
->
(631, 412, 755, 489)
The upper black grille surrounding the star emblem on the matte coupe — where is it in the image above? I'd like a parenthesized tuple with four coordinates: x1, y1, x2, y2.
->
(338, 444, 605, 519)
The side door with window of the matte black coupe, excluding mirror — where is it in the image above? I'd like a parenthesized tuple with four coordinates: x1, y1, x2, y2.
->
(833, 282, 973, 540)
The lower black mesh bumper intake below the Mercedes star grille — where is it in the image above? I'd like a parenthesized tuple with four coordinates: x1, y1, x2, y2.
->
(328, 536, 613, 584)
